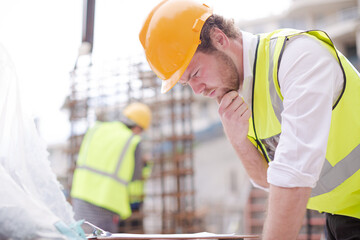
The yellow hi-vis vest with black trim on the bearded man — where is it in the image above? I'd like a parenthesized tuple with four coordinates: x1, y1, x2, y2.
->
(249, 29, 360, 218)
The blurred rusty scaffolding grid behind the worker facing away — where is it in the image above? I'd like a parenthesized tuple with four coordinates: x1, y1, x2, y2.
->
(67, 54, 203, 233)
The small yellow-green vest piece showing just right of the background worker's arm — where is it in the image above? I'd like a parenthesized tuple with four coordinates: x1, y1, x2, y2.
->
(129, 160, 152, 204)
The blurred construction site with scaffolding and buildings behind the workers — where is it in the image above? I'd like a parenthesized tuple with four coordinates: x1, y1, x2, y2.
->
(44, 0, 360, 239)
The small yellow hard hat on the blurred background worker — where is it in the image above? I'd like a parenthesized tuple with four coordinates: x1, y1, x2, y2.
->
(123, 102, 151, 130)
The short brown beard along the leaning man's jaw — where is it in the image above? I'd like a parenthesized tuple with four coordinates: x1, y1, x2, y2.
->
(214, 50, 240, 103)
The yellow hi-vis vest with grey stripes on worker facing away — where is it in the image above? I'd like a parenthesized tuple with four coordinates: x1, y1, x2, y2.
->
(71, 122, 140, 219)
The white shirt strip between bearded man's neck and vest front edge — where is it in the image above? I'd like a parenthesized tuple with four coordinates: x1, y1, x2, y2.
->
(239, 31, 258, 107)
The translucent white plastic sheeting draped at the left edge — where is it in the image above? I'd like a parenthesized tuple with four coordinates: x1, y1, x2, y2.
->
(0, 45, 75, 239)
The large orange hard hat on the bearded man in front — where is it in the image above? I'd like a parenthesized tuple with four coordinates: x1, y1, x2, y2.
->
(139, 0, 212, 93)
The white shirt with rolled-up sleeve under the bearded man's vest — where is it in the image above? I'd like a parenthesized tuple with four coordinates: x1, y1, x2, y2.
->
(239, 31, 344, 188)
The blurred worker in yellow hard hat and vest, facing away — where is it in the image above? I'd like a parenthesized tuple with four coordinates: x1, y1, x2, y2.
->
(71, 102, 151, 233)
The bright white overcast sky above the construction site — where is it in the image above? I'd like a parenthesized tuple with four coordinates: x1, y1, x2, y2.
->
(0, 0, 290, 144)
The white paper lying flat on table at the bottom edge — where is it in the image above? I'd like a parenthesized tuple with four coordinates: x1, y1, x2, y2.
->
(107, 232, 235, 239)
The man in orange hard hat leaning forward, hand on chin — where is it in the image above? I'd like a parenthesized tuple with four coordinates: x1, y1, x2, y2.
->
(139, 0, 360, 240)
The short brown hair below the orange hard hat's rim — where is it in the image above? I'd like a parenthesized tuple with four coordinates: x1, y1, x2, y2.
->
(197, 14, 240, 53)
